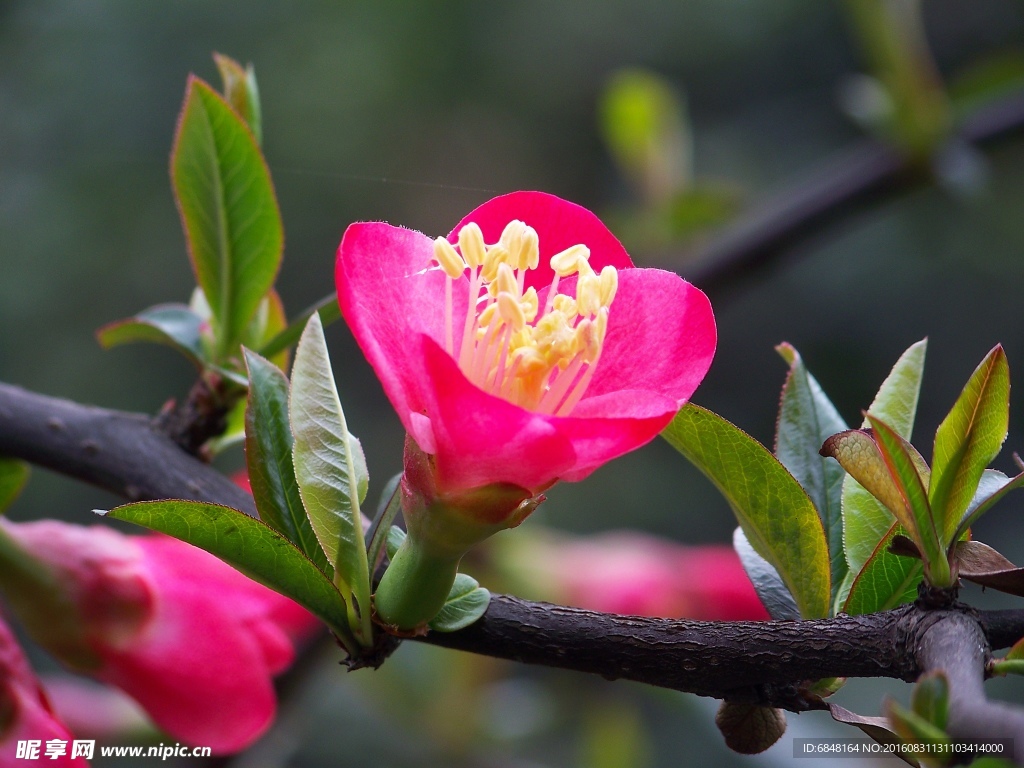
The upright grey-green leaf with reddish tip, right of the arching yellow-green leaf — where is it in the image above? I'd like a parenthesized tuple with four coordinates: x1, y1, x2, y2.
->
(775, 343, 847, 598)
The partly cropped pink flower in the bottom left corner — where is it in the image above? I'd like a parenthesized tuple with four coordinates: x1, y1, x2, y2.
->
(0, 622, 88, 768)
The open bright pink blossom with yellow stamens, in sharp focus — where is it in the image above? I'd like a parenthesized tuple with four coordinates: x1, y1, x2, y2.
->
(336, 193, 716, 498)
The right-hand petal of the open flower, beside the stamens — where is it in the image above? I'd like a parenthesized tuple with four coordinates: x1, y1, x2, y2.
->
(573, 269, 718, 405)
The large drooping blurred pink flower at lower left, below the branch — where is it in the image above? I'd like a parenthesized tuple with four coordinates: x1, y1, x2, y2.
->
(2, 520, 311, 753)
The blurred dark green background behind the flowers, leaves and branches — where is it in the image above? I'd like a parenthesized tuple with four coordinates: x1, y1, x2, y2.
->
(0, 0, 1024, 768)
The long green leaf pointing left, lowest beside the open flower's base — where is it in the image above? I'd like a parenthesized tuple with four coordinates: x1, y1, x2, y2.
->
(105, 500, 358, 652)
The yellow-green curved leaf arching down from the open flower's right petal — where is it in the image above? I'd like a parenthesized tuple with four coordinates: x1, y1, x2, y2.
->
(662, 403, 830, 618)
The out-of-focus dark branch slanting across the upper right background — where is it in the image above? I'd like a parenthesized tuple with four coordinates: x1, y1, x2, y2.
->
(684, 94, 1024, 294)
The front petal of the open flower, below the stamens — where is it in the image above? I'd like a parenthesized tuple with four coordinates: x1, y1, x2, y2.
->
(420, 336, 575, 488)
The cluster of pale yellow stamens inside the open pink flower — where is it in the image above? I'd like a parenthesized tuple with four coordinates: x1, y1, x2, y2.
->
(434, 221, 618, 416)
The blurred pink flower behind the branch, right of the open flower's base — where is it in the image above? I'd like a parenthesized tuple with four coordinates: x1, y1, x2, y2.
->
(502, 531, 769, 621)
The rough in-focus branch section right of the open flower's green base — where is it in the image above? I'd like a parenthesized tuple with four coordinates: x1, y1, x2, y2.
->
(425, 595, 930, 711)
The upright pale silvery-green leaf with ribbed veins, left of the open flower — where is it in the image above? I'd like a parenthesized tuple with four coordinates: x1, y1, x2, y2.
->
(289, 314, 372, 638)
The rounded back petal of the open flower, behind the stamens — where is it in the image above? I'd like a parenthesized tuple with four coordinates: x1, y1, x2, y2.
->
(449, 191, 633, 291)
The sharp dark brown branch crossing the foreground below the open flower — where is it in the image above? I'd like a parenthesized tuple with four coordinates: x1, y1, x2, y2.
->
(6, 384, 1024, 710)
